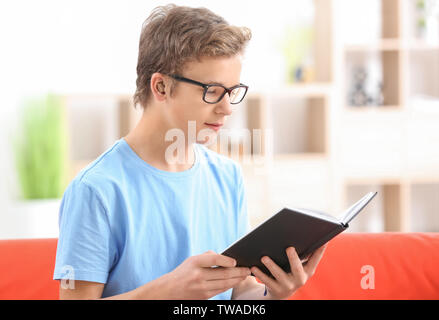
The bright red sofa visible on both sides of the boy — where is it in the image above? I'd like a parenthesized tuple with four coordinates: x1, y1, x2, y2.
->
(0, 233, 439, 300)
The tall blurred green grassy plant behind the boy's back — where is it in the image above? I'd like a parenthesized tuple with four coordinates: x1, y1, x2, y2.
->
(13, 94, 67, 199)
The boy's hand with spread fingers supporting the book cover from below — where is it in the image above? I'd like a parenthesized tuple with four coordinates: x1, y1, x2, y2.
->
(251, 245, 327, 299)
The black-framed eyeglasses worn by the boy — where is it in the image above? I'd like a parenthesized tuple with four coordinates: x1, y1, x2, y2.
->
(169, 75, 248, 104)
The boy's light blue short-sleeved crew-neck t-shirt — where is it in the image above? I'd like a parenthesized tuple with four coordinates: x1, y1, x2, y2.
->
(53, 138, 249, 299)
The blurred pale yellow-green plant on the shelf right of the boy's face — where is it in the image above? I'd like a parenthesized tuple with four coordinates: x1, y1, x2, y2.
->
(282, 26, 314, 83)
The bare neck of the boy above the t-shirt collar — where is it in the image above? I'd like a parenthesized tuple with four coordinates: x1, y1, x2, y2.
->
(124, 110, 195, 172)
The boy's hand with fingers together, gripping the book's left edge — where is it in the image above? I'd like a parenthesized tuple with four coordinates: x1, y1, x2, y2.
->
(164, 251, 250, 300)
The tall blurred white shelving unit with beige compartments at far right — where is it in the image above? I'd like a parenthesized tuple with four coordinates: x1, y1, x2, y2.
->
(335, 0, 439, 231)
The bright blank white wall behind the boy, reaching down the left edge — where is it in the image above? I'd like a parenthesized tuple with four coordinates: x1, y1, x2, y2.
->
(0, 0, 313, 238)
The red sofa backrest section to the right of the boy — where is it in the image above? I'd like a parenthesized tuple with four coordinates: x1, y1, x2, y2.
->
(292, 232, 439, 300)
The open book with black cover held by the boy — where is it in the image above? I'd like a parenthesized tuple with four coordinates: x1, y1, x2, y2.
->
(222, 192, 377, 275)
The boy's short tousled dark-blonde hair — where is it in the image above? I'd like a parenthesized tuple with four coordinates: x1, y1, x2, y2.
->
(133, 4, 251, 108)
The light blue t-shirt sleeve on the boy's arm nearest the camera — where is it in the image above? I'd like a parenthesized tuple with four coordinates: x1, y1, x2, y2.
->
(53, 180, 116, 283)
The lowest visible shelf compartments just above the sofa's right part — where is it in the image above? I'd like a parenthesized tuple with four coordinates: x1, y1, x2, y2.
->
(345, 177, 439, 232)
